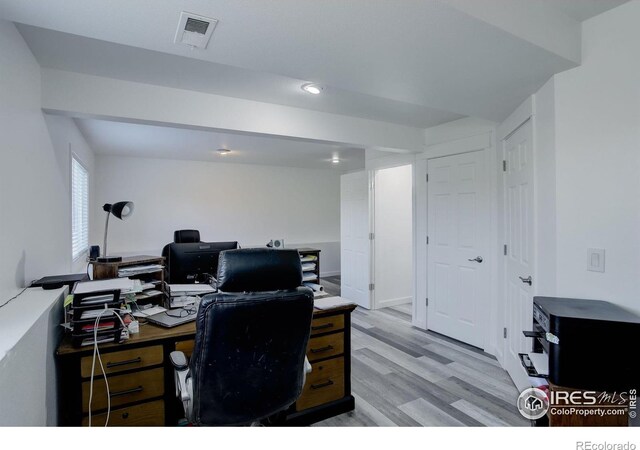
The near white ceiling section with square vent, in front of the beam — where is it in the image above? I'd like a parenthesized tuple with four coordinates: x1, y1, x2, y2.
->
(0, 0, 604, 126)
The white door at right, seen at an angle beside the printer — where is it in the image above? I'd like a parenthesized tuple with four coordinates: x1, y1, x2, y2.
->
(503, 120, 535, 390)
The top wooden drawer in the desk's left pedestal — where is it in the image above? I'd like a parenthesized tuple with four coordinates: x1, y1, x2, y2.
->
(80, 345, 163, 378)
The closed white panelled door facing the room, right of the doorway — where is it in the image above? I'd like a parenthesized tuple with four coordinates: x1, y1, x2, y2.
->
(427, 151, 491, 348)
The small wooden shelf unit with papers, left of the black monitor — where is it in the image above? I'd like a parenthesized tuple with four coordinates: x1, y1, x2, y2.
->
(92, 255, 165, 304)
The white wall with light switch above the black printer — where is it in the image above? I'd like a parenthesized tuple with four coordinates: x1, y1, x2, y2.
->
(555, 1, 640, 313)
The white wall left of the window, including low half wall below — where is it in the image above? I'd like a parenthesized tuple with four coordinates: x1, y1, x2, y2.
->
(0, 20, 90, 426)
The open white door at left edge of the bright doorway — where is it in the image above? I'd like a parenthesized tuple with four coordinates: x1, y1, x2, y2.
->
(340, 171, 371, 308)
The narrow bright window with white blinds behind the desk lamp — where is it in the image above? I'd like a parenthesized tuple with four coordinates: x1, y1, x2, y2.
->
(71, 155, 89, 261)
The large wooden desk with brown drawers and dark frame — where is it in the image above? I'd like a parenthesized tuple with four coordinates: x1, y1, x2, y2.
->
(57, 306, 355, 426)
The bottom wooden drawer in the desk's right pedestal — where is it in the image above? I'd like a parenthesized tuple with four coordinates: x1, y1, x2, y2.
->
(296, 357, 344, 411)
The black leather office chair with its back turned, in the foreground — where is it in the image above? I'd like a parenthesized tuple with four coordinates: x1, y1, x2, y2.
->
(171, 248, 313, 426)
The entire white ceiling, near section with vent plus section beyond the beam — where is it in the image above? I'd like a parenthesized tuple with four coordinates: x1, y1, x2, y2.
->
(0, 0, 625, 171)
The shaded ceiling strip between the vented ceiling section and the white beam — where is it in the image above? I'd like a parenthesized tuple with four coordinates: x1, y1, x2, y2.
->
(18, 25, 463, 128)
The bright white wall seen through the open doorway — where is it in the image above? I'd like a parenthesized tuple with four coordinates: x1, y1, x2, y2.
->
(374, 165, 413, 309)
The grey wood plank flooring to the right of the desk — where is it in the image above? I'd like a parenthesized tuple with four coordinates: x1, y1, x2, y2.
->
(313, 276, 530, 427)
